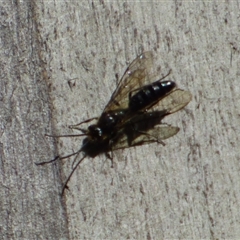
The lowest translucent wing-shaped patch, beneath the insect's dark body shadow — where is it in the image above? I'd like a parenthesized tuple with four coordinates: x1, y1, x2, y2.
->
(112, 124, 179, 150)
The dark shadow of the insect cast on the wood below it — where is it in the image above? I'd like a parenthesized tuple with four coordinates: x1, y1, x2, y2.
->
(36, 111, 179, 195)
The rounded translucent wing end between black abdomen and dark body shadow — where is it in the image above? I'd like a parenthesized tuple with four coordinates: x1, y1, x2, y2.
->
(151, 89, 192, 115)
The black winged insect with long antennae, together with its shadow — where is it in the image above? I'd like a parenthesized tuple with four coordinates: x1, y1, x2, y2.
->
(36, 52, 192, 194)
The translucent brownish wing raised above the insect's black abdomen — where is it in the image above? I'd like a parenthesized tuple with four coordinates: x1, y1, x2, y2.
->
(104, 52, 153, 112)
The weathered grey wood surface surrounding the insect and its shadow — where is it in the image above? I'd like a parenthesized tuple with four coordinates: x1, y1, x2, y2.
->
(0, 1, 240, 239)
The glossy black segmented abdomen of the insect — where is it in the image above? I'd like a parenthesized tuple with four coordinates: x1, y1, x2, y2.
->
(129, 81, 176, 111)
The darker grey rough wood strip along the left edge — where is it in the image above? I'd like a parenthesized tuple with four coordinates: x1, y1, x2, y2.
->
(0, 1, 68, 239)
